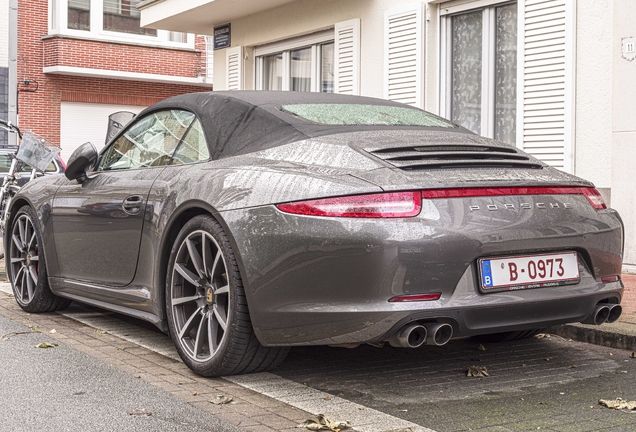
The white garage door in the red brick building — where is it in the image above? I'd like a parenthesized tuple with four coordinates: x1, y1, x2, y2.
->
(59, 102, 145, 162)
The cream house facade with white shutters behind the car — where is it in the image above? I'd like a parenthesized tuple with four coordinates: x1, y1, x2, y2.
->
(140, 0, 636, 265)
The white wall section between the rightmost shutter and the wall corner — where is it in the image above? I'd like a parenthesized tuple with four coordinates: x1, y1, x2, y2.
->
(574, 0, 614, 188)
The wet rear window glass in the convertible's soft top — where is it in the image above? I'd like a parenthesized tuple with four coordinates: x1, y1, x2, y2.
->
(282, 104, 456, 128)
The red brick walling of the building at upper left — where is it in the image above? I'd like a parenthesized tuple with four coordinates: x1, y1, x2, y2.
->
(18, 0, 210, 143)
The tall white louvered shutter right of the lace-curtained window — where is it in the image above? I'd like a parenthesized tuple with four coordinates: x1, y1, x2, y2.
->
(518, 0, 574, 172)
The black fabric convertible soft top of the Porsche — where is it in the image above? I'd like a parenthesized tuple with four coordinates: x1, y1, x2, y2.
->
(140, 91, 467, 159)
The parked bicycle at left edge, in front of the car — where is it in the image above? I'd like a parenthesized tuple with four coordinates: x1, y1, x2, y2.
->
(0, 119, 61, 259)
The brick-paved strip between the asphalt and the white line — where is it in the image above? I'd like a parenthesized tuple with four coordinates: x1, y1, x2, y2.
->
(0, 292, 312, 432)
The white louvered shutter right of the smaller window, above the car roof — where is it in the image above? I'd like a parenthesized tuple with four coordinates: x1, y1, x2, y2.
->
(334, 18, 360, 95)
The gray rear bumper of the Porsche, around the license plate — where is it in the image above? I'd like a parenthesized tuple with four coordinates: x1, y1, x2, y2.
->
(220, 196, 623, 346)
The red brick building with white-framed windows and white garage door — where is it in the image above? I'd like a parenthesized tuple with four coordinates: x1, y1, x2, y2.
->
(8, 0, 211, 160)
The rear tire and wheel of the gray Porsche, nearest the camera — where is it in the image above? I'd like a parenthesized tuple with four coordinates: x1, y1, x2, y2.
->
(166, 215, 289, 376)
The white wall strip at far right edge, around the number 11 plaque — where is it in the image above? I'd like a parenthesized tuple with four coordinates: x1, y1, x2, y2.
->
(611, 0, 636, 265)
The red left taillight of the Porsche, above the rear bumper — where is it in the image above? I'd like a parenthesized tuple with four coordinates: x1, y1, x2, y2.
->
(276, 192, 422, 218)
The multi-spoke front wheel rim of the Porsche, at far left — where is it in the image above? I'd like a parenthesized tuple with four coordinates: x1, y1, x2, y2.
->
(9, 214, 40, 303)
